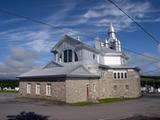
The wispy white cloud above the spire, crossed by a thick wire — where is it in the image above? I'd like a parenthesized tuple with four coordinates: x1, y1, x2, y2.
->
(80, 1, 151, 30)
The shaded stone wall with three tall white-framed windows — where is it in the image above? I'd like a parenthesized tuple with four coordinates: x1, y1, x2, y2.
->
(19, 80, 66, 101)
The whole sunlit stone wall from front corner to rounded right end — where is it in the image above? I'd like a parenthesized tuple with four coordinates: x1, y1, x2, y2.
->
(66, 69, 141, 103)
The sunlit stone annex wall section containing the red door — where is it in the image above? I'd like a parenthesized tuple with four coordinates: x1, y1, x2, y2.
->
(66, 79, 99, 103)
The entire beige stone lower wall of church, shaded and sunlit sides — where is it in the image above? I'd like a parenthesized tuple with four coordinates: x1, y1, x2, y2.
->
(19, 69, 141, 103)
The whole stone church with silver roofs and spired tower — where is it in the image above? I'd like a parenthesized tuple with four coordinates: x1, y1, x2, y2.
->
(18, 23, 140, 103)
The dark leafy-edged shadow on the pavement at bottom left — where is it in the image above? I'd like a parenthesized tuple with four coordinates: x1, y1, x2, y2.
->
(7, 112, 48, 120)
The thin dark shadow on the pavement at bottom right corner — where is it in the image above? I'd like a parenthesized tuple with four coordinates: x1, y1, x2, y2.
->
(120, 115, 160, 120)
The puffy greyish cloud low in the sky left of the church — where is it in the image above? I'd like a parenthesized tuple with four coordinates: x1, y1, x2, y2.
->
(0, 48, 39, 79)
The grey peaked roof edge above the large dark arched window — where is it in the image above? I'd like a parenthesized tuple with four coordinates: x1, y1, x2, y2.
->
(51, 35, 100, 53)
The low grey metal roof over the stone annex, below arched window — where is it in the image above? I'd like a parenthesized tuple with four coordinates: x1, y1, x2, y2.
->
(17, 63, 99, 78)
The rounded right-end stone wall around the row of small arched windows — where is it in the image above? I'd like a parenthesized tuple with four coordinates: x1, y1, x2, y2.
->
(100, 69, 141, 98)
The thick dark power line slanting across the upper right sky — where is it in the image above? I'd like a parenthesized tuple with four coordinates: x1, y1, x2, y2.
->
(108, 0, 160, 44)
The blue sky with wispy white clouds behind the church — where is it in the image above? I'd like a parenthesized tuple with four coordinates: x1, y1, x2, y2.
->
(0, 0, 160, 79)
